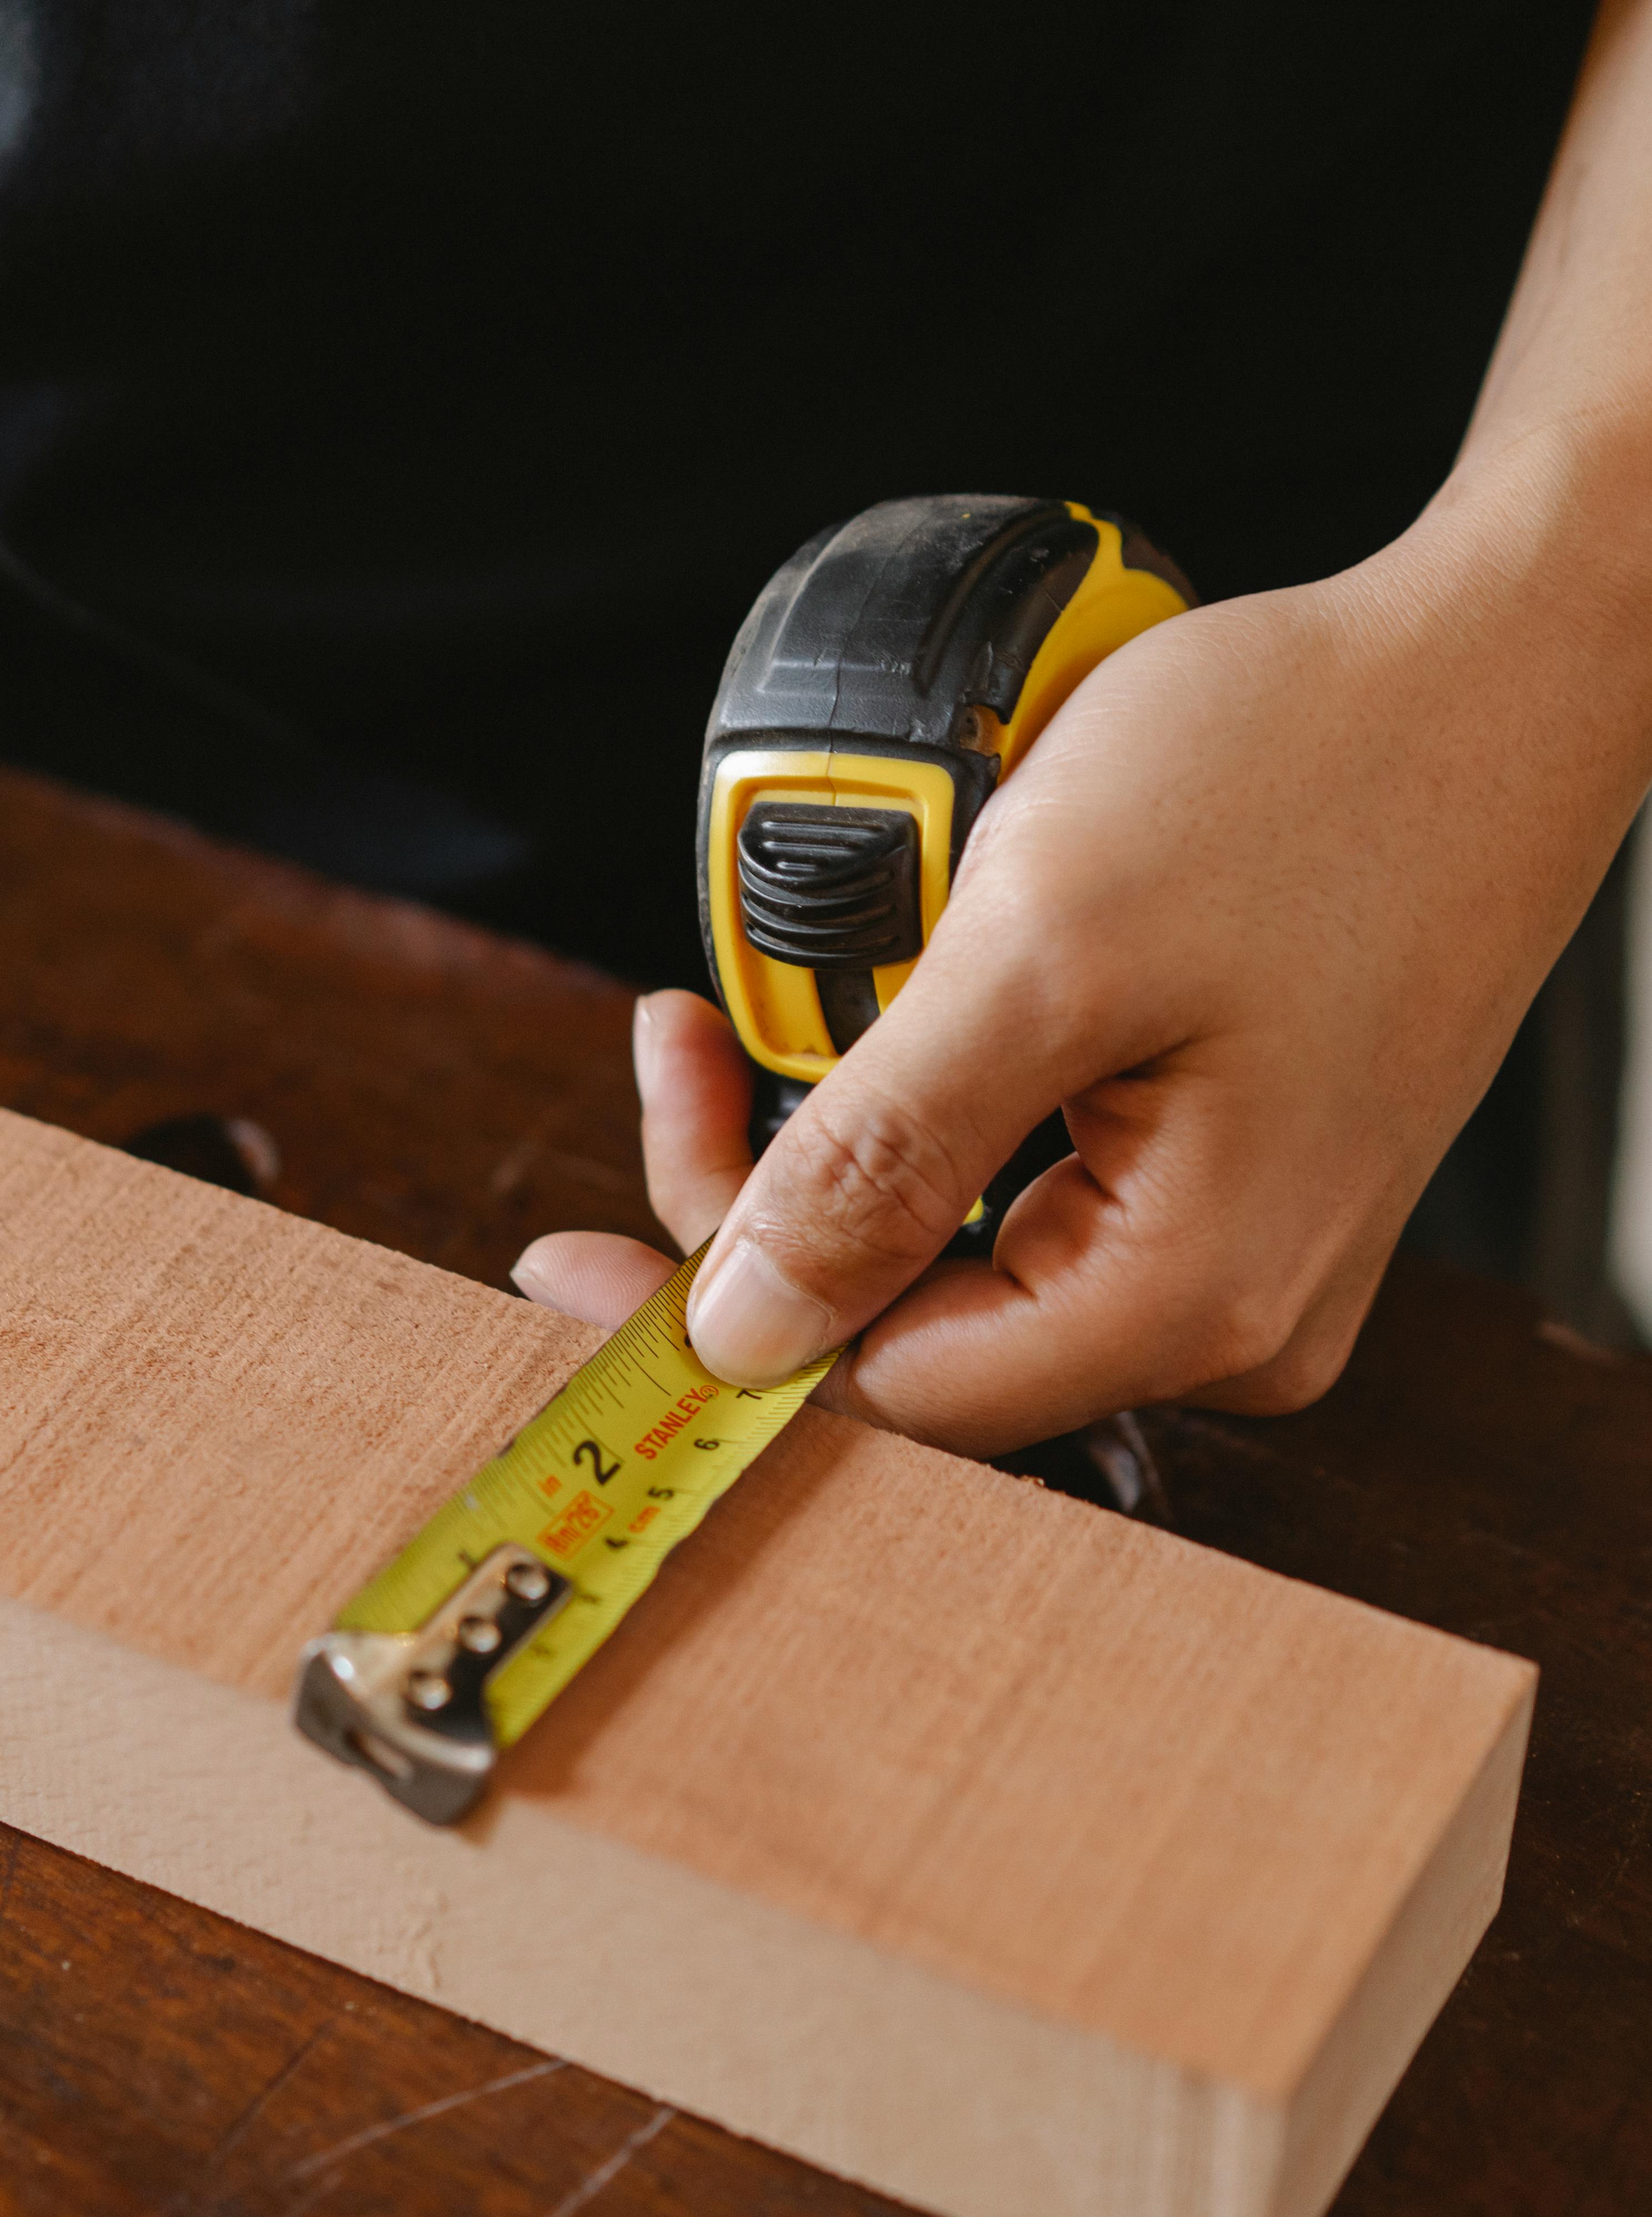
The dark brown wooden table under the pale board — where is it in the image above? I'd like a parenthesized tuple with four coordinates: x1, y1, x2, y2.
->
(0, 776, 1652, 2217)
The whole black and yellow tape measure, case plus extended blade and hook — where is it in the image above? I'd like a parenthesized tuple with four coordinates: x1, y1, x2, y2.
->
(297, 495, 1193, 1825)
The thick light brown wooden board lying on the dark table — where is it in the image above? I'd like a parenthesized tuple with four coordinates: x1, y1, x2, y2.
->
(0, 1117, 1535, 2217)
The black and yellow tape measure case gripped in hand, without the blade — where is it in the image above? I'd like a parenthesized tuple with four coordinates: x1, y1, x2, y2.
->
(699, 492, 1195, 1255)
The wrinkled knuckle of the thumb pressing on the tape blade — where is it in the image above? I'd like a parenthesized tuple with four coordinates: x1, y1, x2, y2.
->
(787, 1098, 967, 1268)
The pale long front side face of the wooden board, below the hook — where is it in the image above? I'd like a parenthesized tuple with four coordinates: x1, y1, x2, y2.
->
(0, 1601, 1286, 2217)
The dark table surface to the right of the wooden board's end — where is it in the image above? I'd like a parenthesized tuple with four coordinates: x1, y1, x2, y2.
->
(1148, 1286, 1652, 2217)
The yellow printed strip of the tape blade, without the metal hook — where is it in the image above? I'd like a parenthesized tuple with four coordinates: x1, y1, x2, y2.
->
(335, 1239, 836, 1747)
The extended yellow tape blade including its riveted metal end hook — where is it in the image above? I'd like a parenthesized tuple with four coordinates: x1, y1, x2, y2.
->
(295, 1242, 836, 1825)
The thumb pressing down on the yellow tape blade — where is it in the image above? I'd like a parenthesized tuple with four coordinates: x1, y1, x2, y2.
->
(688, 871, 1073, 1388)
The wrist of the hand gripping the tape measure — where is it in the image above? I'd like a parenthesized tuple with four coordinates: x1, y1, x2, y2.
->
(1259, 414, 1652, 991)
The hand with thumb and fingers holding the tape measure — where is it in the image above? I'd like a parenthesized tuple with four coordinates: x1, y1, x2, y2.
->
(519, 472, 1648, 1454)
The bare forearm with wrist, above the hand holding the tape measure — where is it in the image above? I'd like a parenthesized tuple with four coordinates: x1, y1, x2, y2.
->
(1322, 0, 1652, 991)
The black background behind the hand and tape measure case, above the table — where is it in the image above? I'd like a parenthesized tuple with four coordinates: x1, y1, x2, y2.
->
(0, 0, 1614, 1314)
